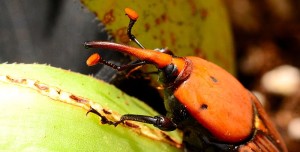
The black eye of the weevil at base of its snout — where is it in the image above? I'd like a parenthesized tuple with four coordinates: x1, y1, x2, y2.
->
(159, 63, 178, 84)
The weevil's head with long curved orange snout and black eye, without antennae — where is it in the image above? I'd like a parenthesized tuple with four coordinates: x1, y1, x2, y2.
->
(84, 41, 191, 86)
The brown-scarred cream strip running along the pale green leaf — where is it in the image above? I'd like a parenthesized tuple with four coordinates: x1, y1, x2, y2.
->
(0, 75, 181, 148)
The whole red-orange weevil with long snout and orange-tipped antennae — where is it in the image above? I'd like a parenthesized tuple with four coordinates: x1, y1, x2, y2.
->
(85, 9, 287, 152)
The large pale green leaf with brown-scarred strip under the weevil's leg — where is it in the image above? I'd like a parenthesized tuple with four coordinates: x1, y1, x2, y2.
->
(0, 64, 181, 151)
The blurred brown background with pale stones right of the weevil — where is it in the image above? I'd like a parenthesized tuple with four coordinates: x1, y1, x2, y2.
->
(224, 0, 300, 152)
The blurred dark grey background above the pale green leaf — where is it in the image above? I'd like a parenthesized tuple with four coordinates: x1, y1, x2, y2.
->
(0, 0, 105, 73)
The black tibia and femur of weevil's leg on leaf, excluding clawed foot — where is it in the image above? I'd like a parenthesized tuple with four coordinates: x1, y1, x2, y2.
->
(115, 114, 177, 131)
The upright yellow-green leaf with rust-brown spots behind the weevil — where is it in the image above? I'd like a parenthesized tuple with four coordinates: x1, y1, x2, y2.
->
(81, 0, 235, 73)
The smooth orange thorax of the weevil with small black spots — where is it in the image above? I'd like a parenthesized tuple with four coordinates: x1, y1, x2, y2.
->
(174, 57, 254, 144)
